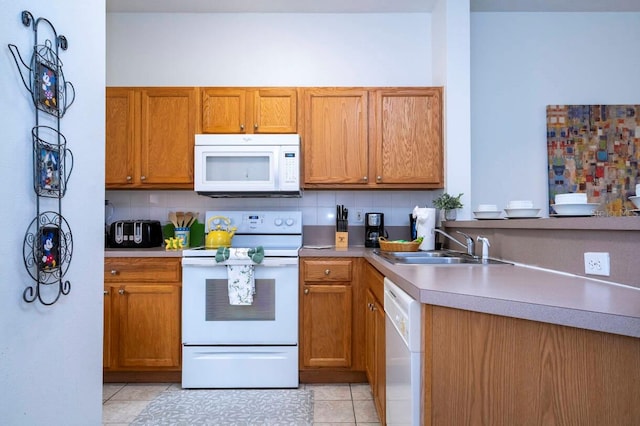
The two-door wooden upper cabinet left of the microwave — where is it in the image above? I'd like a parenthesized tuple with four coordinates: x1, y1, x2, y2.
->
(105, 87, 198, 189)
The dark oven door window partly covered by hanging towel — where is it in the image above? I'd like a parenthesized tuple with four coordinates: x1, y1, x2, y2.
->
(205, 279, 276, 321)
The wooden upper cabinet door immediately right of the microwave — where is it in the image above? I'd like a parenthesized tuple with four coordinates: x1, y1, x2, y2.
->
(303, 88, 369, 188)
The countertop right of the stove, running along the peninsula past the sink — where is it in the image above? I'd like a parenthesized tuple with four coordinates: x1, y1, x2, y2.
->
(300, 247, 640, 337)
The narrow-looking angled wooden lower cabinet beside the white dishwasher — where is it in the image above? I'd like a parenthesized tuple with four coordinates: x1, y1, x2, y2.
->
(363, 263, 386, 424)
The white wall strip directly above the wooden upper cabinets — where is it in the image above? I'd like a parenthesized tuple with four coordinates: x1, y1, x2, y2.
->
(107, 13, 431, 86)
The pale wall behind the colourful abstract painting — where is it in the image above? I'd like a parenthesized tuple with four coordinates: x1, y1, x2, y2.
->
(471, 13, 640, 215)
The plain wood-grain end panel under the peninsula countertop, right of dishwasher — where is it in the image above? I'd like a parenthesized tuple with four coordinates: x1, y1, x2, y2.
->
(423, 305, 640, 426)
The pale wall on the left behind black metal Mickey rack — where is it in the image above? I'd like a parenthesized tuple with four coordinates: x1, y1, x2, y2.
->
(0, 0, 105, 425)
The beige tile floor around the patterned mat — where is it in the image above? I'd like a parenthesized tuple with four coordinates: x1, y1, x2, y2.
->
(102, 383, 380, 426)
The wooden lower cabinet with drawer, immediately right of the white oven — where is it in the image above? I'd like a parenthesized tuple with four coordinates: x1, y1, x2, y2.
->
(299, 258, 365, 383)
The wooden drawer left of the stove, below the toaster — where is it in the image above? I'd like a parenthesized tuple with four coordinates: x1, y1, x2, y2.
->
(104, 257, 181, 283)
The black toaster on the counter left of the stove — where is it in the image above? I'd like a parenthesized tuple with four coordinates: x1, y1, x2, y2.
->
(109, 220, 163, 248)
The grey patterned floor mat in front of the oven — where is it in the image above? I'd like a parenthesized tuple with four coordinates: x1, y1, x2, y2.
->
(131, 389, 313, 426)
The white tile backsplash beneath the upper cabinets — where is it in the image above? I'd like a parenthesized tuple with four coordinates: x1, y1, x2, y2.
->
(105, 190, 441, 230)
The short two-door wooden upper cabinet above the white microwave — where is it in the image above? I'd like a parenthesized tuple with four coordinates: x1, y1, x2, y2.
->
(201, 87, 298, 133)
